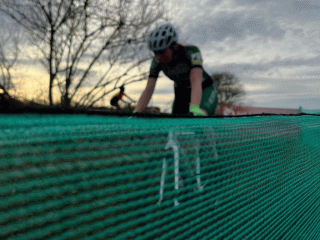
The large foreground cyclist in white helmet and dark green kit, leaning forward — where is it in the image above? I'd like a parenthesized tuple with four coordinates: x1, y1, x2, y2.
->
(135, 24, 218, 116)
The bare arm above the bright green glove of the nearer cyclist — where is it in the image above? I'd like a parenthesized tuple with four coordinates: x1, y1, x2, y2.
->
(190, 67, 203, 106)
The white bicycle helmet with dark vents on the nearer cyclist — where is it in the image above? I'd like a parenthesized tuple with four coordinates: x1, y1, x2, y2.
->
(148, 24, 178, 51)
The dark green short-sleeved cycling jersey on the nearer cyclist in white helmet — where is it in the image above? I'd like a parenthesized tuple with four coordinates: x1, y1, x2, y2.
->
(149, 45, 212, 88)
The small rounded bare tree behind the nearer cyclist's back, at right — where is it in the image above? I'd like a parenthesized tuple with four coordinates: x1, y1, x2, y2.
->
(211, 72, 245, 105)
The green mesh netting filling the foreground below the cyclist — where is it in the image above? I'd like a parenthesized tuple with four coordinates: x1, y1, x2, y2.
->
(0, 114, 320, 240)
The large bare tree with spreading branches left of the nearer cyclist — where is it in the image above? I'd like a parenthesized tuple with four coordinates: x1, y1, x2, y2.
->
(0, 0, 165, 107)
